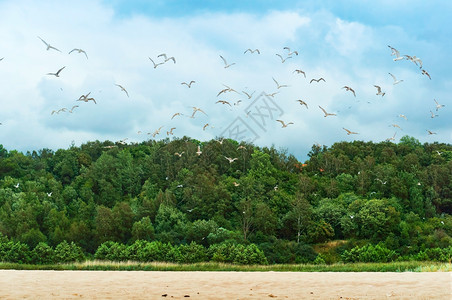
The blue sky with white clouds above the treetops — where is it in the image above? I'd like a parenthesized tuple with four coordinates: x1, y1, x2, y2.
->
(0, 0, 452, 161)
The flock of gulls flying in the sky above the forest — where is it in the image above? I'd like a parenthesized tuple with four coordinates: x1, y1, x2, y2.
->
(0, 36, 445, 158)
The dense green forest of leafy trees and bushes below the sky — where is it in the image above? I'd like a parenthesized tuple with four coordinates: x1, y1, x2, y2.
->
(0, 136, 452, 264)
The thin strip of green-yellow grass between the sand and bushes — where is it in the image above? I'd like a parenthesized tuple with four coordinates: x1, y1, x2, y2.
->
(0, 260, 452, 272)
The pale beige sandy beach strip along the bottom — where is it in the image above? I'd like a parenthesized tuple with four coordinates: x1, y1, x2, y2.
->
(0, 270, 452, 300)
